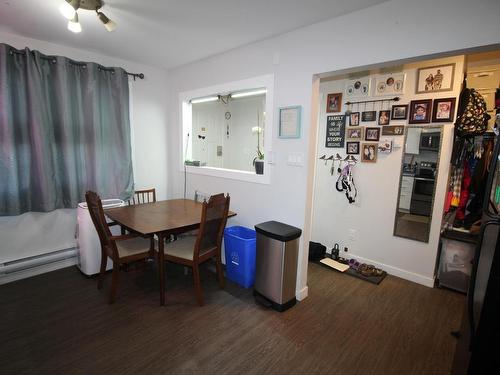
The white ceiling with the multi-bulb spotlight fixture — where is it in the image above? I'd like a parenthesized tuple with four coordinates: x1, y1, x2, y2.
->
(0, 0, 386, 69)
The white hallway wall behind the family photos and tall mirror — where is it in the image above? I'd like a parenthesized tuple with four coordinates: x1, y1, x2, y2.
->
(311, 56, 464, 286)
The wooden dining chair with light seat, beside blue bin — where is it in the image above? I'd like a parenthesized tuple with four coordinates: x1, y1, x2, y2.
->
(158, 194, 230, 306)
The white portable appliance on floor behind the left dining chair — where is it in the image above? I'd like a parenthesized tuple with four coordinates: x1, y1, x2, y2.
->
(76, 199, 125, 276)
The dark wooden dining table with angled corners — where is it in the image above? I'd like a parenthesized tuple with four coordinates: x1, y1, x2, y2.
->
(105, 199, 236, 305)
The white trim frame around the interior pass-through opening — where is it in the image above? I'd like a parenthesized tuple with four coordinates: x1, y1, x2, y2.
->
(179, 74, 274, 184)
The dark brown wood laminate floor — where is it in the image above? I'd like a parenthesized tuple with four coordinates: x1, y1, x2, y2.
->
(0, 264, 464, 375)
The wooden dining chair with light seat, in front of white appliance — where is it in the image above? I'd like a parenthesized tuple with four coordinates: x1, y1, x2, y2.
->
(85, 191, 154, 303)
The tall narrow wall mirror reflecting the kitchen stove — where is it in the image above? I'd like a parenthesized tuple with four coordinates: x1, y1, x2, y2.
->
(394, 126, 443, 242)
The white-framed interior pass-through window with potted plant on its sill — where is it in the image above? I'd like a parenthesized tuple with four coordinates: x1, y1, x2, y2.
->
(180, 75, 274, 183)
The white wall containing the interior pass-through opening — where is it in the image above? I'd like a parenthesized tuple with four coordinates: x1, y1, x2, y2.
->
(168, 0, 500, 298)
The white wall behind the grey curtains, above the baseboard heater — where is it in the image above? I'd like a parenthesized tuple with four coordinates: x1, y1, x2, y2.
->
(0, 33, 168, 263)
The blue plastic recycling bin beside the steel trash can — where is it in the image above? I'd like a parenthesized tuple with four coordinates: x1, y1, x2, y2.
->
(224, 226, 257, 288)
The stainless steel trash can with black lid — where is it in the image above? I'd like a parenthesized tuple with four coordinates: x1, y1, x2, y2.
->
(254, 221, 302, 311)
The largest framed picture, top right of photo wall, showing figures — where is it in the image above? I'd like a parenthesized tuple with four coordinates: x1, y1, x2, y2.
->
(416, 63, 455, 94)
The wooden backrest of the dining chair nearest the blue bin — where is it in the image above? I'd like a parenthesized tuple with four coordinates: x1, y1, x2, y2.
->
(194, 194, 230, 258)
